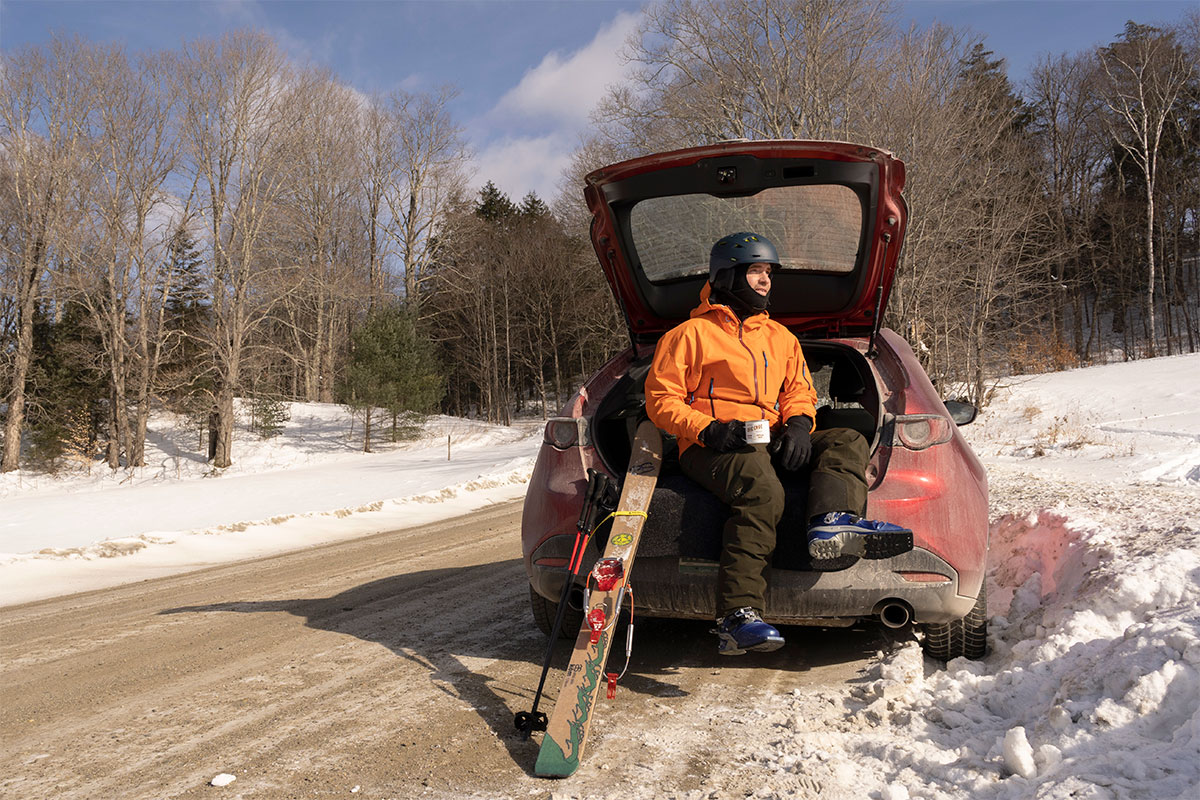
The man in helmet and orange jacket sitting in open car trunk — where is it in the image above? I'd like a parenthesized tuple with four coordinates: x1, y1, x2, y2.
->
(646, 233, 912, 655)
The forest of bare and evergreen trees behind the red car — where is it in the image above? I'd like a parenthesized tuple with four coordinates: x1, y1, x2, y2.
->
(0, 0, 1200, 471)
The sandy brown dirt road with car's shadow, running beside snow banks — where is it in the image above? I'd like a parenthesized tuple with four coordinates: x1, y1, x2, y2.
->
(0, 503, 882, 800)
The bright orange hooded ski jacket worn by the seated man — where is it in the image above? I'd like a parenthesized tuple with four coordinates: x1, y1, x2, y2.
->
(646, 283, 817, 452)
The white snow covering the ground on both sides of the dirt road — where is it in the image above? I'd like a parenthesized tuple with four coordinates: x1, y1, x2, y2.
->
(0, 355, 1200, 800)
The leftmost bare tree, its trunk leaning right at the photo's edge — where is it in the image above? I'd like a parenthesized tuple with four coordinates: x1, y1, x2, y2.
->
(0, 40, 91, 473)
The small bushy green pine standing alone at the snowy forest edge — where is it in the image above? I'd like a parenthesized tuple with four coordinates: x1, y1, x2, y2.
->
(342, 306, 445, 452)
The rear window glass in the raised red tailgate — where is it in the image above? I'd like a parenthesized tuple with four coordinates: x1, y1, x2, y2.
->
(629, 185, 863, 283)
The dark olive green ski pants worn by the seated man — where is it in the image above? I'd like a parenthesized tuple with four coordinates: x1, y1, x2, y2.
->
(679, 428, 870, 618)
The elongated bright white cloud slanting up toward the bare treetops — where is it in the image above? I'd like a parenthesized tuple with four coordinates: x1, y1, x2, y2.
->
(490, 11, 640, 128)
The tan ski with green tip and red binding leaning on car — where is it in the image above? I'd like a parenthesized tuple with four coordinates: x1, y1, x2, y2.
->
(534, 420, 662, 777)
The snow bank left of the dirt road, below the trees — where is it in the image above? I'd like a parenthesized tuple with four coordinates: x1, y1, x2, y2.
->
(0, 403, 542, 606)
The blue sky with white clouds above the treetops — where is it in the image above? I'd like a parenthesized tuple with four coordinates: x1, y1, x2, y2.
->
(0, 0, 1195, 200)
